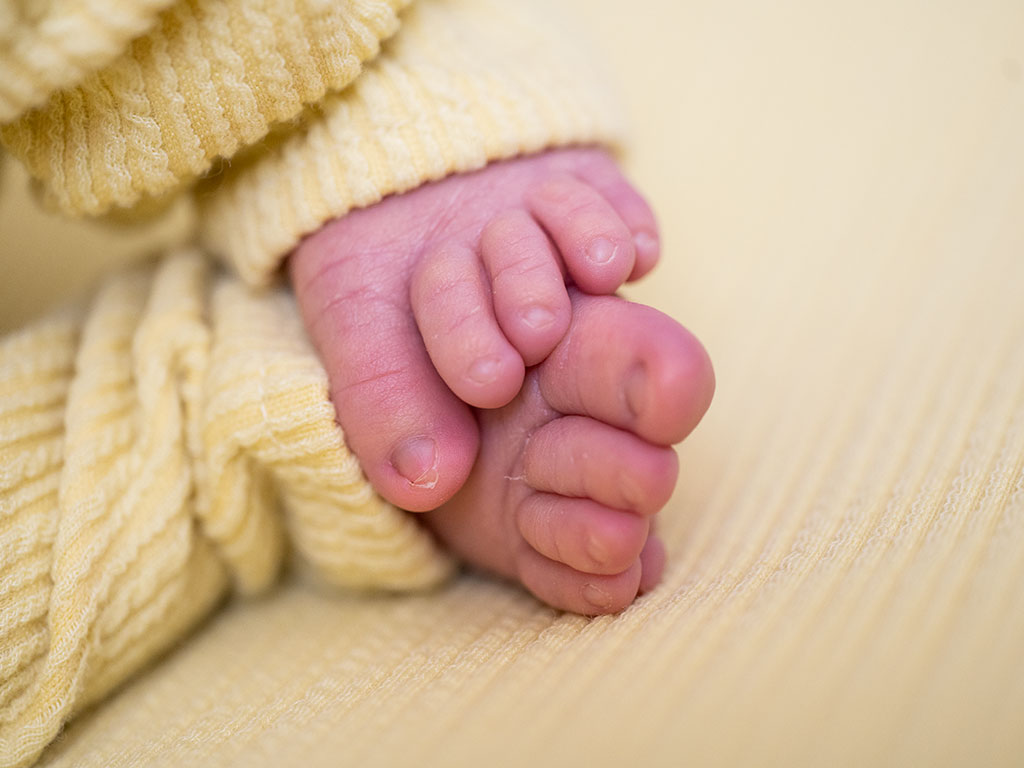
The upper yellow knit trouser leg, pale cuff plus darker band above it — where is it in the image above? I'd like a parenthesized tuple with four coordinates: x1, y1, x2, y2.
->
(0, 0, 618, 284)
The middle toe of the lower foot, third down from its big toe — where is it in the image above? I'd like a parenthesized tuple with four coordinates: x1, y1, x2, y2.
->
(516, 494, 649, 575)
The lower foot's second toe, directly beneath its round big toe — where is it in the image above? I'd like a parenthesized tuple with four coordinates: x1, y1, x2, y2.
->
(523, 416, 679, 518)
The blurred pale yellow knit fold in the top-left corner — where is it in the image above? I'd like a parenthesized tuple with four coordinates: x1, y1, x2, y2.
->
(0, 0, 173, 124)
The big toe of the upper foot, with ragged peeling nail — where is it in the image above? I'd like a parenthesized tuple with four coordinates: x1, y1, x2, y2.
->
(290, 246, 479, 511)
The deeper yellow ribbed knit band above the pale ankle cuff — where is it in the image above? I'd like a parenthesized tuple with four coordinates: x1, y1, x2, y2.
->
(0, 0, 411, 215)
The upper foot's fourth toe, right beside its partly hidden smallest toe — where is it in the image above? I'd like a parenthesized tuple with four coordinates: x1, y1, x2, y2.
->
(526, 174, 636, 294)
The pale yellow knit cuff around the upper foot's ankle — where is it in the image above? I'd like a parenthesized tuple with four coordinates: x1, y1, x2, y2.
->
(197, 0, 620, 284)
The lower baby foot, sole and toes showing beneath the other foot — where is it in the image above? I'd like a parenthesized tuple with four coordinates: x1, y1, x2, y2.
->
(423, 292, 715, 615)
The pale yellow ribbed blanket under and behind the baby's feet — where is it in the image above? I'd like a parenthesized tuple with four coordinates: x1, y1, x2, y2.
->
(0, 0, 1024, 765)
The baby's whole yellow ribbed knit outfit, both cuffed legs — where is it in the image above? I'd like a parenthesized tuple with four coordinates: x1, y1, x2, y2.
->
(0, 0, 615, 766)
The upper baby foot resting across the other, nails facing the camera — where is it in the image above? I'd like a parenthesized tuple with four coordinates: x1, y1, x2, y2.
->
(289, 148, 658, 511)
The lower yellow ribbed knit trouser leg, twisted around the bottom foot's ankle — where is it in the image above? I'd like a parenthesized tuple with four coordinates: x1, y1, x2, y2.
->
(0, 253, 450, 766)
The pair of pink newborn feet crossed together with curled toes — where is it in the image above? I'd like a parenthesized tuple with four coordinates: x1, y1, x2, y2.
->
(289, 150, 714, 614)
